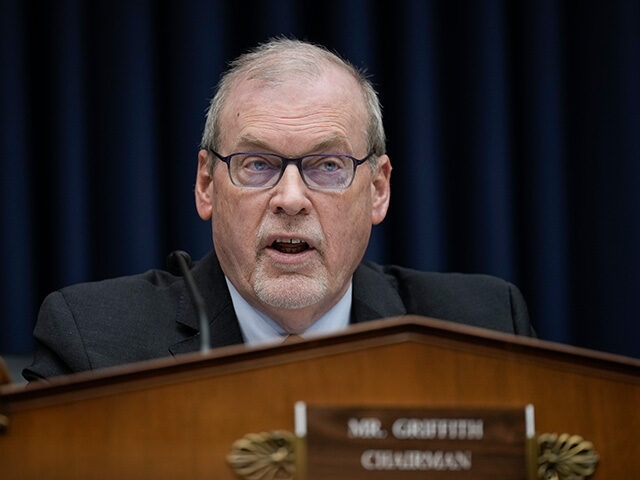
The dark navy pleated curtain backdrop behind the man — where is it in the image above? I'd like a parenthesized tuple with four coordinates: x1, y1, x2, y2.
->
(0, 0, 640, 357)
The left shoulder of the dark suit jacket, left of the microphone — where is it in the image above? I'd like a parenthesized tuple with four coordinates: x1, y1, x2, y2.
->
(23, 270, 188, 380)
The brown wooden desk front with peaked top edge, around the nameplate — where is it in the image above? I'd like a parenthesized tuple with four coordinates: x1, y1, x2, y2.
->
(0, 317, 640, 480)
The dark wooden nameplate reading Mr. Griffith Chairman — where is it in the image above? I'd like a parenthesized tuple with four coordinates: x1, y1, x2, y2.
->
(296, 405, 533, 480)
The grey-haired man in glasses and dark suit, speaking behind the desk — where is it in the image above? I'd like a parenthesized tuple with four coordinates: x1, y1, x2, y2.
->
(24, 39, 532, 380)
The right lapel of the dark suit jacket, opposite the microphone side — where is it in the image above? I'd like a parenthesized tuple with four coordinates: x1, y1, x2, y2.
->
(351, 263, 407, 323)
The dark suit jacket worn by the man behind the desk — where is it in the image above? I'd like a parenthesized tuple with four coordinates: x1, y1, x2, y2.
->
(23, 252, 533, 380)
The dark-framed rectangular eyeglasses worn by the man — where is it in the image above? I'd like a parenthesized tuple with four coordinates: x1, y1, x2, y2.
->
(208, 149, 373, 190)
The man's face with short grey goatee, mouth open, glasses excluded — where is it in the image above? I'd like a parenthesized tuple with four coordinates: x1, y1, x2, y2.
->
(196, 67, 391, 333)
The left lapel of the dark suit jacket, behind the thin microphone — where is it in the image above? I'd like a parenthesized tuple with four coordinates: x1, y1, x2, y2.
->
(169, 251, 243, 355)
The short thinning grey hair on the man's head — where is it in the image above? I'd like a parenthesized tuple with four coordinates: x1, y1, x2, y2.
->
(200, 38, 386, 167)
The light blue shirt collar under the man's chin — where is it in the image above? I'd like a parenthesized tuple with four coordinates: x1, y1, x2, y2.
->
(224, 275, 353, 344)
